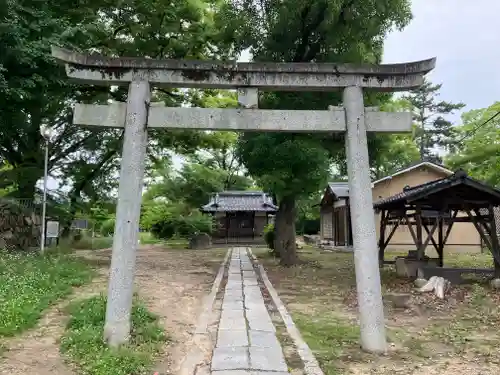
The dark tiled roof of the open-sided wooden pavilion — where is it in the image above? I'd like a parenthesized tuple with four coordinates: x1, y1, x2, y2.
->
(373, 170, 500, 209)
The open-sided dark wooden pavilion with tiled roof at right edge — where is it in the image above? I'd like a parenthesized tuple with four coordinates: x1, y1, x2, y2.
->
(374, 170, 500, 277)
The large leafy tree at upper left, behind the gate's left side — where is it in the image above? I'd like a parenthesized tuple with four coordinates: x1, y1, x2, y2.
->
(0, 0, 234, 232)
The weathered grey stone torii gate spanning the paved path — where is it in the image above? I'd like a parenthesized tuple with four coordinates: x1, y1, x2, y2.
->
(52, 47, 435, 352)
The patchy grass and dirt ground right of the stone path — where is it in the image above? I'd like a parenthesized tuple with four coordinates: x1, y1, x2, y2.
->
(253, 248, 500, 375)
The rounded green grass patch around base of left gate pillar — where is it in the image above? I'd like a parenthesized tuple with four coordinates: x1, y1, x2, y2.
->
(61, 295, 167, 375)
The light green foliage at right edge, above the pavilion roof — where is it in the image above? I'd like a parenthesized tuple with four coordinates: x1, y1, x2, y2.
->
(446, 102, 500, 187)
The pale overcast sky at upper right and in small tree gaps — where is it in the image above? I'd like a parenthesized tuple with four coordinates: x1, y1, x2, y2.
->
(49, 0, 500, 189)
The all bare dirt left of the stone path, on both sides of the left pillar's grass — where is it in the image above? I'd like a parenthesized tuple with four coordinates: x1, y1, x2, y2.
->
(0, 245, 227, 375)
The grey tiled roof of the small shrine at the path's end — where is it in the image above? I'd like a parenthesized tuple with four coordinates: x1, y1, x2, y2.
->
(201, 191, 278, 212)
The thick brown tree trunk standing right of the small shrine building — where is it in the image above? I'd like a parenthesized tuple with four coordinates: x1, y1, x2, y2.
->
(274, 196, 297, 267)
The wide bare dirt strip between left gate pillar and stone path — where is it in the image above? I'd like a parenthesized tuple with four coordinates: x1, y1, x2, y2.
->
(80, 245, 227, 374)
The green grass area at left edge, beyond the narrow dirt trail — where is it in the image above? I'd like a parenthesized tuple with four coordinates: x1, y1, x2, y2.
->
(0, 252, 93, 337)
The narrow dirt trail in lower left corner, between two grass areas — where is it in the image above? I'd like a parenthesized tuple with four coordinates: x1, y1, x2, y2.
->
(0, 270, 106, 375)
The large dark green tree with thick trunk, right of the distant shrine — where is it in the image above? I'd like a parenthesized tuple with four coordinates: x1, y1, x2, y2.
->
(219, 0, 411, 266)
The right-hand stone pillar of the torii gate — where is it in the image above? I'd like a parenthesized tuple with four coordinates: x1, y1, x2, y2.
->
(343, 86, 386, 352)
